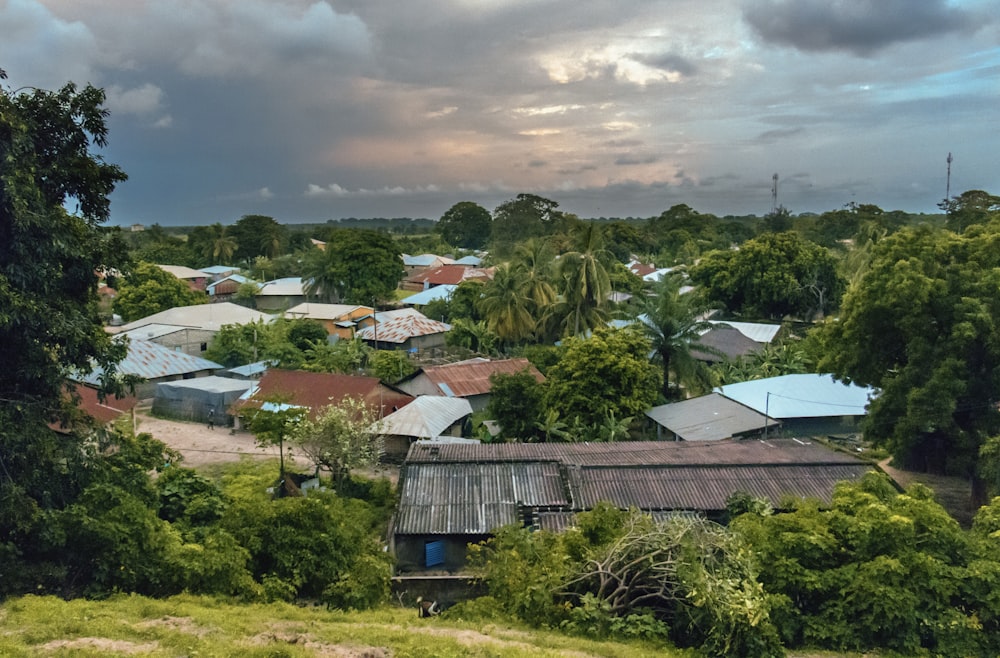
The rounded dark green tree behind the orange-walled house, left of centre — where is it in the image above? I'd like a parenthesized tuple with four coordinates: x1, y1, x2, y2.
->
(306, 229, 404, 305)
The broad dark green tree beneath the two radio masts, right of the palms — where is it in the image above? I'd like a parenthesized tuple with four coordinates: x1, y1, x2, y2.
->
(691, 232, 844, 320)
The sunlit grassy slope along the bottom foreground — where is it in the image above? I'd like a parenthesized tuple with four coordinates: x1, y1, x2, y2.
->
(0, 595, 695, 658)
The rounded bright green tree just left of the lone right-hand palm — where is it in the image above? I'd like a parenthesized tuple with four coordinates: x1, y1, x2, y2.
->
(545, 328, 660, 428)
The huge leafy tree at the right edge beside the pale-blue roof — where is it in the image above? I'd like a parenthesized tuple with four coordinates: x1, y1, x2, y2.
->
(818, 224, 1000, 477)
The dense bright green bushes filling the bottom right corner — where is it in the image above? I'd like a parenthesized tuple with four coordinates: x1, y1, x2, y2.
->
(732, 473, 998, 656)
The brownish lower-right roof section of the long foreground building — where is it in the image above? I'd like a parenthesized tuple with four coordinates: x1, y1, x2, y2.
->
(570, 461, 873, 512)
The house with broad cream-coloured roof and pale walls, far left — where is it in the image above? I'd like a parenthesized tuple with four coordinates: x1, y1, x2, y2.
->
(110, 302, 273, 356)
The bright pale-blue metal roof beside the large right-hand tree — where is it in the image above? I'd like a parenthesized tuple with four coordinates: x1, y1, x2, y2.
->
(715, 375, 874, 420)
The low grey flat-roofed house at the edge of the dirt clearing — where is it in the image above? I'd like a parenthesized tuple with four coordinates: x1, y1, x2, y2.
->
(153, 376, 253, 426)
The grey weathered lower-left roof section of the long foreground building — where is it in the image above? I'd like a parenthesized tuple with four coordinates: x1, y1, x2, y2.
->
(395, 462, 569, 535)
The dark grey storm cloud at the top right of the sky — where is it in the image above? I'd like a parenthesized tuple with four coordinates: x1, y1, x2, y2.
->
(743, 0, 975, 56)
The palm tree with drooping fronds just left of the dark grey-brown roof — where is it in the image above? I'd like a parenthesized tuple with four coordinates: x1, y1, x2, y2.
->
(638, 276, 717, 400)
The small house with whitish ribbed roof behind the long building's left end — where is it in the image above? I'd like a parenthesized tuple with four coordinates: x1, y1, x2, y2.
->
(377, 395, 472, 461)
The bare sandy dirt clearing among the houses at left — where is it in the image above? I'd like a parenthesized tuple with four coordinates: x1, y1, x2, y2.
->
(136, 411, 278, 468)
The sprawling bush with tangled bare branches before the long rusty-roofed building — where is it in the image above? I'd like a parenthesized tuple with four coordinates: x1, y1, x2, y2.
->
(470, 505, 782, 656)
